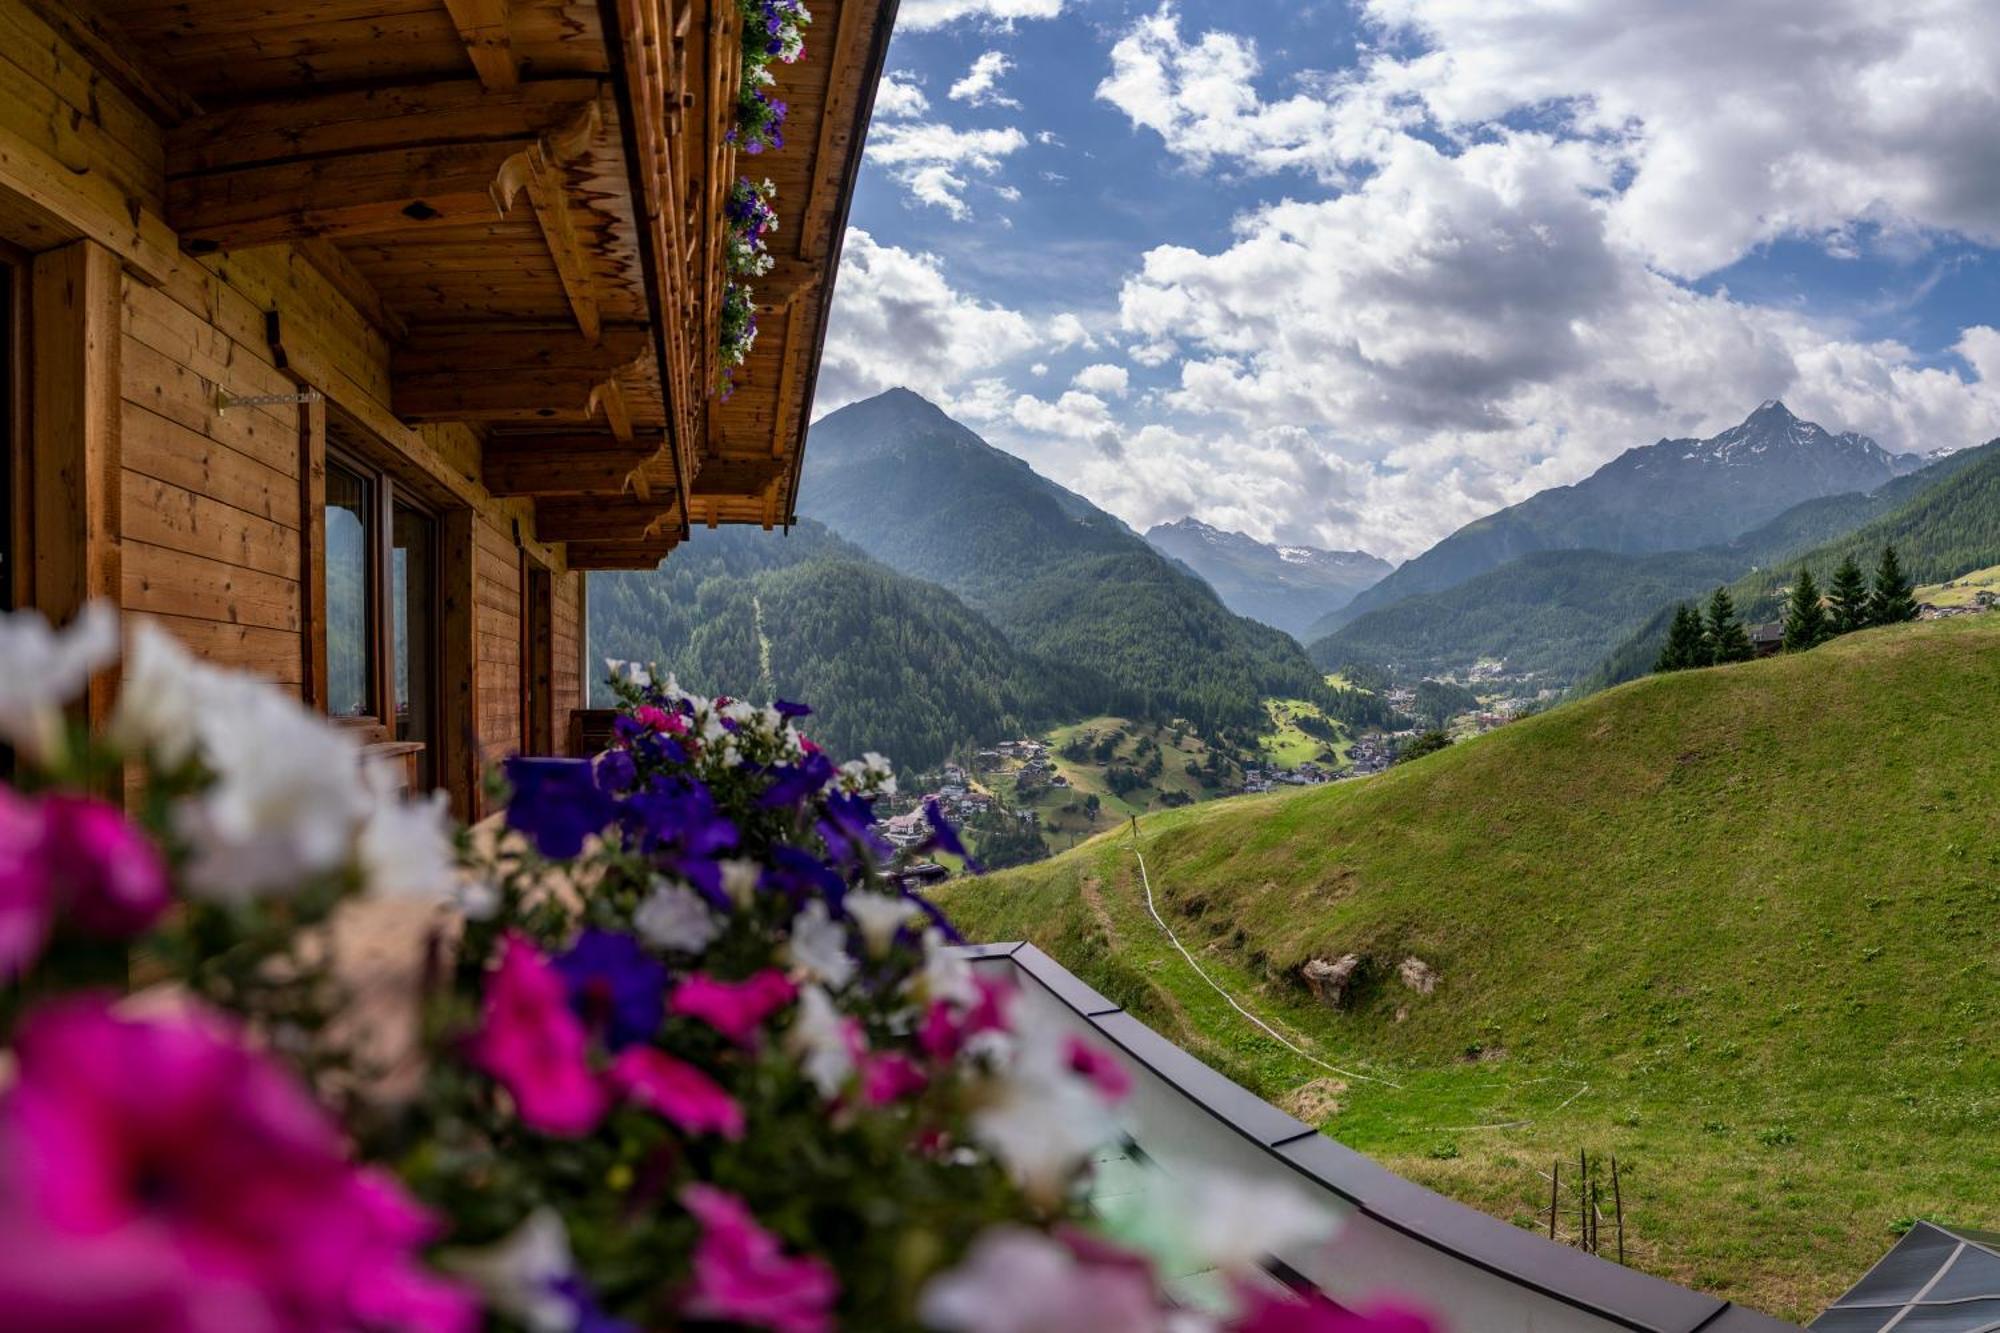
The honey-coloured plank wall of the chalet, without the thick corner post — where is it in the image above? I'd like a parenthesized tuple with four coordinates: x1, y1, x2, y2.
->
(0, 0, 584, 800)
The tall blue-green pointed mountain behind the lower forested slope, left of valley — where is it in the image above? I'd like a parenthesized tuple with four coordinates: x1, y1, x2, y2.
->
(800, 388, 1388, 737)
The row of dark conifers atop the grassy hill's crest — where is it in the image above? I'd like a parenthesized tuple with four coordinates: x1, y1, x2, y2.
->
(1652, 546, 1916, 673)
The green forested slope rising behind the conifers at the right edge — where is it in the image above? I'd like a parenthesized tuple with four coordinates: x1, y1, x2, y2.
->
(1576, 438, 2000, 693)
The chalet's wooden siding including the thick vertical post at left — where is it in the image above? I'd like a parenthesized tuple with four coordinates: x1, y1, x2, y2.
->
(0, 0, 582, 813)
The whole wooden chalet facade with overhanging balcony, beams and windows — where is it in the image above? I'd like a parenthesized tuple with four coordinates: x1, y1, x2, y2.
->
(0, 0, 894, 815)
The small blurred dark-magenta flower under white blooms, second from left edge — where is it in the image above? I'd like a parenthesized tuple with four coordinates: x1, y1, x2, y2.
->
(42, 795, 172, 939)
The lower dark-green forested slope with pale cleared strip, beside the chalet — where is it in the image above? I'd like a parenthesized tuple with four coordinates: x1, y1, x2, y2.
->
(590, 522, 1072, 769)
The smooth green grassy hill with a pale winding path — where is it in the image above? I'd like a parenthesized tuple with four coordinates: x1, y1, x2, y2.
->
(948, 616, 2000, 1319)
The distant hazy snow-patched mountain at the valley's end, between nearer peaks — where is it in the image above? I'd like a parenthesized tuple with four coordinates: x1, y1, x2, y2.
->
(1146, 518, 1394, 636)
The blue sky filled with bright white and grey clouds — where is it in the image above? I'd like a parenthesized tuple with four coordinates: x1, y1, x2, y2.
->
(816, 0, 2000, 558)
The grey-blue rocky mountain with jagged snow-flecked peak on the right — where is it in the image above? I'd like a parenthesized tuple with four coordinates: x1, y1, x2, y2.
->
(1308, 400, 1926, 638)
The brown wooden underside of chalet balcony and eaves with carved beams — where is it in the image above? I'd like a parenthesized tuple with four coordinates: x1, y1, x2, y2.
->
(98, 0, 894, 568)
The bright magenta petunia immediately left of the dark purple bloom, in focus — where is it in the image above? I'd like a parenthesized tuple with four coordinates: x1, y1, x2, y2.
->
(472, 931, 610, 1135)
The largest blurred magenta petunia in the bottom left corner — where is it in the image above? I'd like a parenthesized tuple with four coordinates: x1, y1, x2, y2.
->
(0, 997, 478, 1333)
